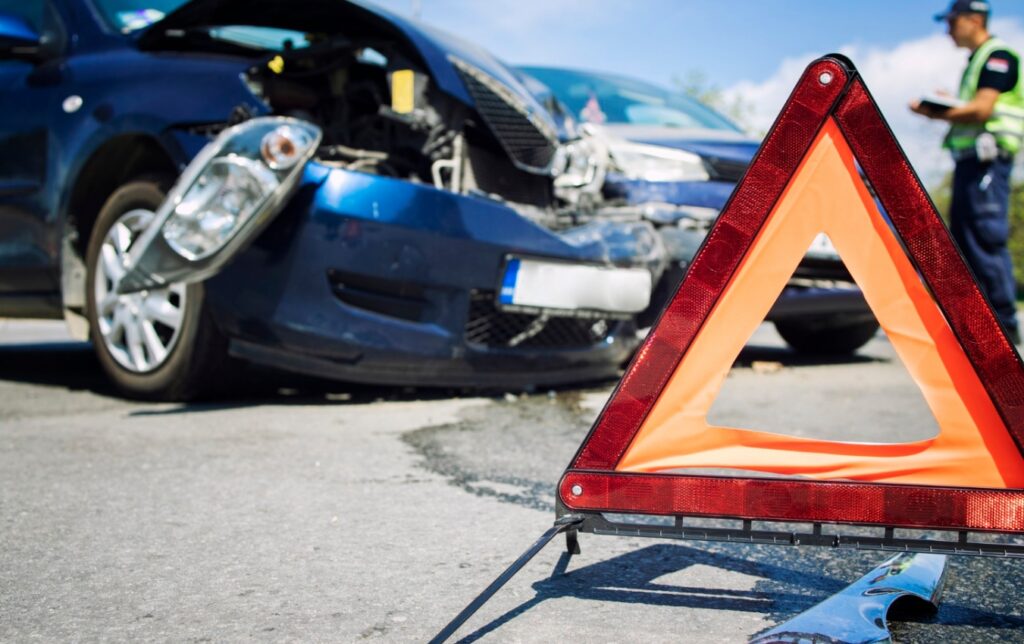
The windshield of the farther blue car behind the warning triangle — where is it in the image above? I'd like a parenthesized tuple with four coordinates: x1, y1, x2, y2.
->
(521, 67, 742, 132)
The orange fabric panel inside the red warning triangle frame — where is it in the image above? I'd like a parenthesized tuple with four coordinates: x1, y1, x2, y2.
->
(615, 118, 1024, 488)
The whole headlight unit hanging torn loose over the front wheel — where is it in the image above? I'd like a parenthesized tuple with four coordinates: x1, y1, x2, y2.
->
(118, 117, 323, 293)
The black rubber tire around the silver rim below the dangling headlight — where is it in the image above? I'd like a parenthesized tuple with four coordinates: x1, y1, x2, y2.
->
(86, 177, 227, 400)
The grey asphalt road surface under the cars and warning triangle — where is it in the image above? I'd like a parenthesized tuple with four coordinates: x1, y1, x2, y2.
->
(0, 320, 1024, 642)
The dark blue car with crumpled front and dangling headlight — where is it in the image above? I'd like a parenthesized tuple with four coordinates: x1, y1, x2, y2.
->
(0, 0, 665, 399)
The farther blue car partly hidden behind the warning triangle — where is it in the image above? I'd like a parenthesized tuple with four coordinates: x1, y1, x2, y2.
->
(520, 67, 879, 353)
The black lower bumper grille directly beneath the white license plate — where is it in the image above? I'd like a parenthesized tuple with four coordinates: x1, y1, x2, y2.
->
(465, 291, 615, 349)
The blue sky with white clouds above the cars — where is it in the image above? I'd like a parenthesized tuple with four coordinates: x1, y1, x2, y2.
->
(370, 0, 1024, 183)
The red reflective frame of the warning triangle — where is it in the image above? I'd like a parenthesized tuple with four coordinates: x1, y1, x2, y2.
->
(558, 54, 1024, 532)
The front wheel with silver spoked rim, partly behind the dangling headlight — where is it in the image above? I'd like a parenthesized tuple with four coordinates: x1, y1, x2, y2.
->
(86, 179, 226, 400)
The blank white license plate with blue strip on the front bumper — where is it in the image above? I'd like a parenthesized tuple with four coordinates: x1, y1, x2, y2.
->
(499, 257, 651, 313)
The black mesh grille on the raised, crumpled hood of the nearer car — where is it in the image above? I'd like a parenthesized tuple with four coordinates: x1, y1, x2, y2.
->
(452, 57, 558, 172)
